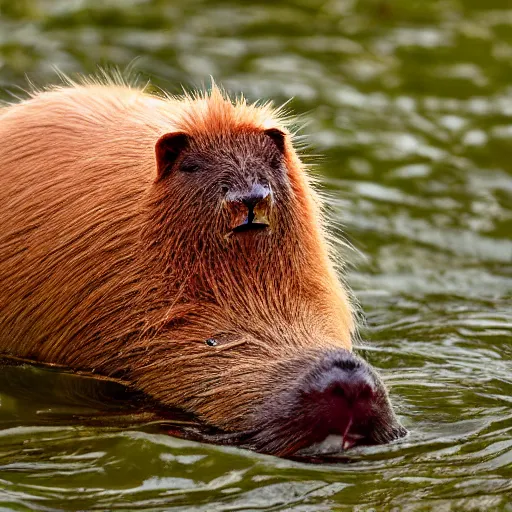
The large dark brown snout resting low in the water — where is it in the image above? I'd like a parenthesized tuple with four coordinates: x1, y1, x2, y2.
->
(262, 349, 407, 454)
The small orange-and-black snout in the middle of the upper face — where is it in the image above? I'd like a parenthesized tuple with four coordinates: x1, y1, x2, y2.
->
(225, 183, 272, 233)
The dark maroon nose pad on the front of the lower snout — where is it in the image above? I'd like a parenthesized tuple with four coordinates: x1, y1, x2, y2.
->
(301, 350, 378, 433)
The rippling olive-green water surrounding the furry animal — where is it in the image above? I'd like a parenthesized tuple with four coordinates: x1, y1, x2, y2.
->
(0, 0, 512, 512)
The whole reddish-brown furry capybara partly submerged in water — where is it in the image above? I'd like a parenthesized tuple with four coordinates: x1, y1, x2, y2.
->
(0, 80, 406, 456)
